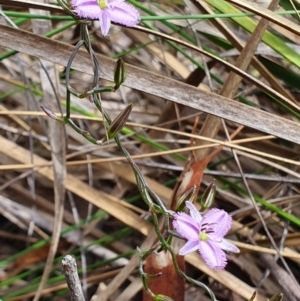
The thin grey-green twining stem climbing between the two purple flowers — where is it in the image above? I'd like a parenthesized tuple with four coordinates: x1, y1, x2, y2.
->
(64, 23, 216, 301)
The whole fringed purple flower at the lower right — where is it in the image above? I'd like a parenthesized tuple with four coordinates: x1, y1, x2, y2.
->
(173, 202, 240, 269)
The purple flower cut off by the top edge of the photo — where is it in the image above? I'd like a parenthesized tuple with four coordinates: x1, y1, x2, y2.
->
(71, 0, 140, 36)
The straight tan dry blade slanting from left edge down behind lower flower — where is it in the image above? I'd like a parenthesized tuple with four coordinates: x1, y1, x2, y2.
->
(0, 137, 265, 301)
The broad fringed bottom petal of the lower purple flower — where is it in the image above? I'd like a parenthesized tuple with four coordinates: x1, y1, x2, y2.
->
(199, 240, 227, 270)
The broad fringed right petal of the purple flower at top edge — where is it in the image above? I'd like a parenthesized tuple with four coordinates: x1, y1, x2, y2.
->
(107, 1, 140, 27)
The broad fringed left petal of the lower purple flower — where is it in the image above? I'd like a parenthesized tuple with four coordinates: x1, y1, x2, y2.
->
(173, 212, 199, 240)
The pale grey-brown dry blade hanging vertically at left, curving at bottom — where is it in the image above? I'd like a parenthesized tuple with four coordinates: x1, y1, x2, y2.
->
(30, 0, 66, 301)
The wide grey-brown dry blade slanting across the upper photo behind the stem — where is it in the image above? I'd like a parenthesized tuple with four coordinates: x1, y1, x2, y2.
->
(0, 25, 300, 144)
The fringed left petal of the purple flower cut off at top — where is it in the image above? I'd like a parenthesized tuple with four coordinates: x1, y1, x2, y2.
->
(71, 0, 103, 19)
